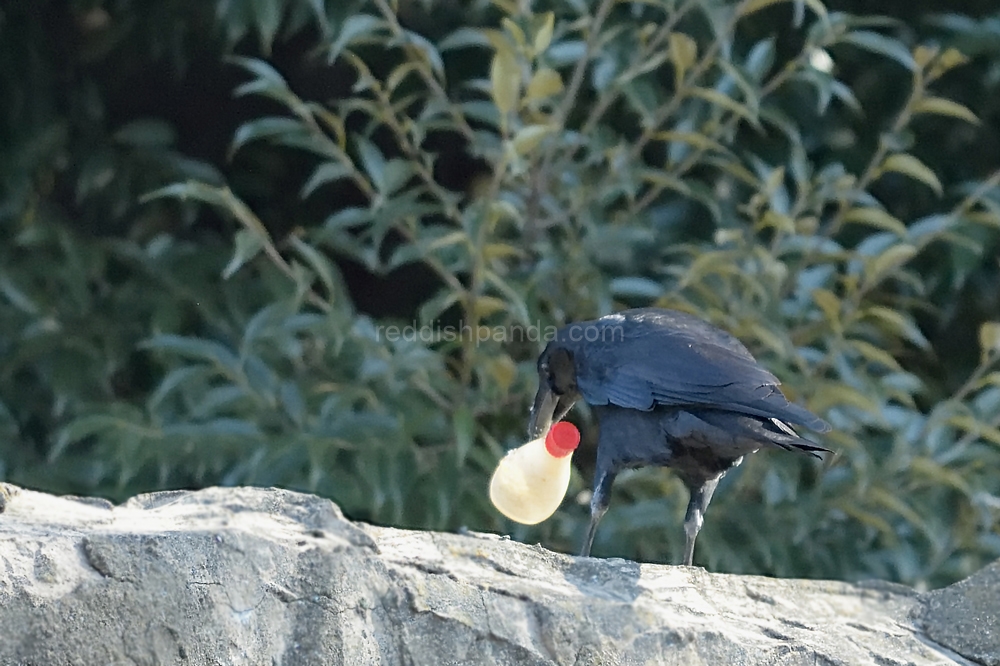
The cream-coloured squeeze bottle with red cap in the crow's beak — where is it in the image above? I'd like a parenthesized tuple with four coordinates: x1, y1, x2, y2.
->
(490, 421, 580, 525)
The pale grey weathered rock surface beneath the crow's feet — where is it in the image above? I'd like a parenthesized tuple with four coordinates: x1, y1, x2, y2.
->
(0, 486, 988, 666)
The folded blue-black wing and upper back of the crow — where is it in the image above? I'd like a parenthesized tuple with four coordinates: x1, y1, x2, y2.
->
(558, 308, 829, 431)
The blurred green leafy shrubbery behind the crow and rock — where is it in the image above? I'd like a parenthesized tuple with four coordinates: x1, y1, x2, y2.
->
(0, 0, 1000, 586)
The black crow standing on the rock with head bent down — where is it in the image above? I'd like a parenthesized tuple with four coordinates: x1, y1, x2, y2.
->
(528, 308, 830, 565)
